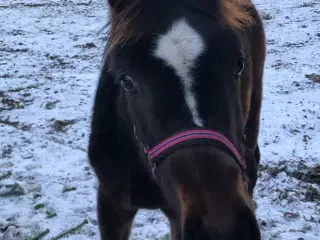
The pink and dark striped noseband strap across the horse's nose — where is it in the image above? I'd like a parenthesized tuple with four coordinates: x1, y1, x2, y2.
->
(144, 129, 247, 174)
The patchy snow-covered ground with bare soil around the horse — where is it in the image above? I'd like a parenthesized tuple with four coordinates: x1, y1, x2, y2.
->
(0, 0, 320, 240)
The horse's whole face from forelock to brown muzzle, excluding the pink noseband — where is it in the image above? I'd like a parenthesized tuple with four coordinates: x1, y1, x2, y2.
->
(104, 1, 260, 240)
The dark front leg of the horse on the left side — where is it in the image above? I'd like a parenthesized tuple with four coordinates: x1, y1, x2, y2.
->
(98, 185, 137, 240)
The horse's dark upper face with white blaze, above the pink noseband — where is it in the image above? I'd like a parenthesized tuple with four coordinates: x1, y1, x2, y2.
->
(110, 19, 246, 147)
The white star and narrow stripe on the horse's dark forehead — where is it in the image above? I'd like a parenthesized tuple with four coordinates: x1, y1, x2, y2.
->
(154, 19, 205, 126)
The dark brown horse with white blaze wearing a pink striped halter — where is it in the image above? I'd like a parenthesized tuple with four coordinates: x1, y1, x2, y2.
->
(88, 0, 266, 240)
